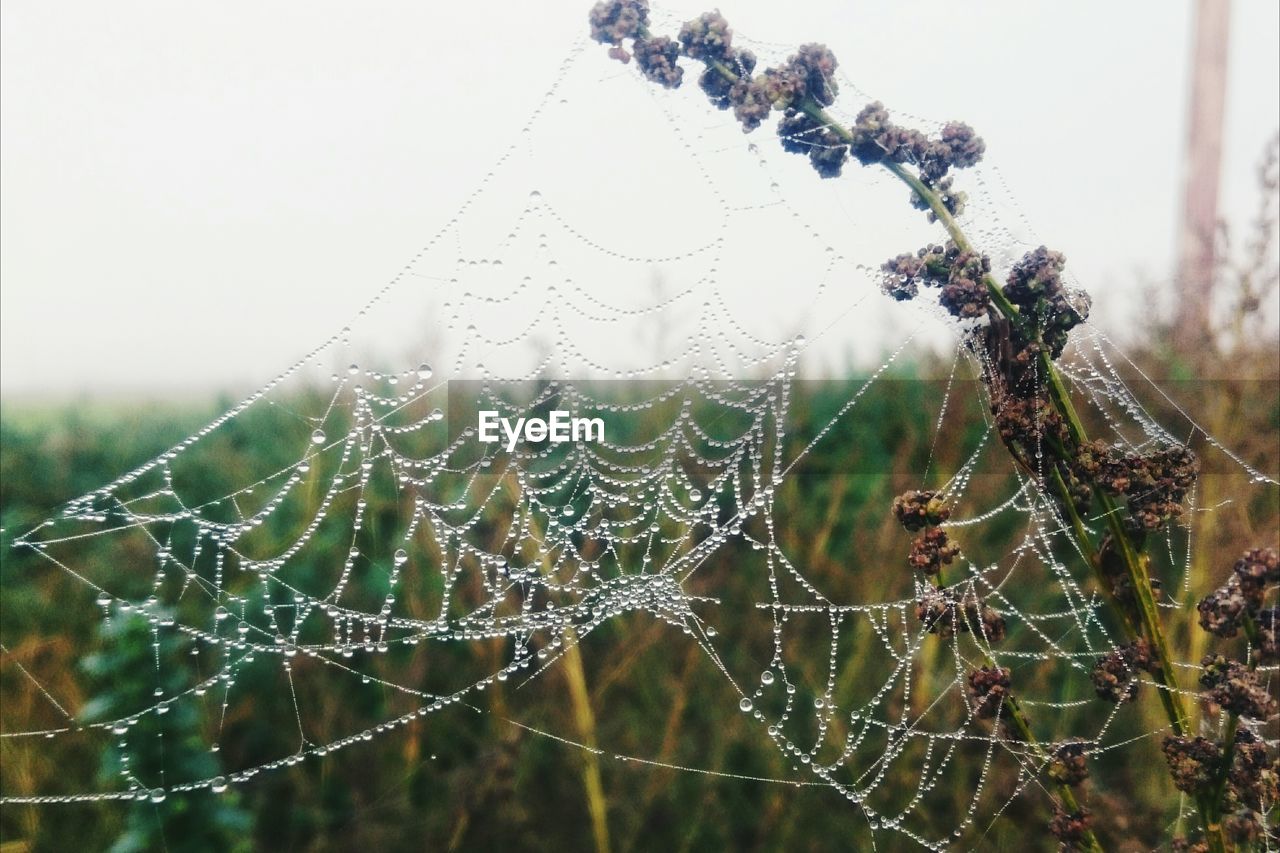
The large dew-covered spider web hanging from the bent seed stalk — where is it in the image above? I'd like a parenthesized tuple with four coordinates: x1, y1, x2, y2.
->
(0, 16, 1275, 848)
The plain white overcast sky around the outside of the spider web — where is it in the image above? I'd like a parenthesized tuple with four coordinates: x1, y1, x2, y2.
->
(0, 0, 1280, 397)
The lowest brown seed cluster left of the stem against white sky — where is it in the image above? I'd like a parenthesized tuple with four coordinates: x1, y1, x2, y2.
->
(881, 242, 991, 320)
